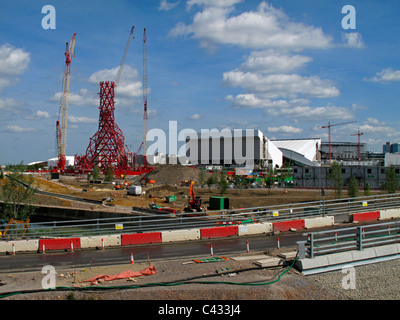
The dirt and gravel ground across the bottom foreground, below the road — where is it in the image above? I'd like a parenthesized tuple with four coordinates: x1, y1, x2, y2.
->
(0, 253, 400, 301)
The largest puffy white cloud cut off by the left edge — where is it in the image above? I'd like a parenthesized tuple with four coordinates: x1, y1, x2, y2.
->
(0, 43, 30, 91)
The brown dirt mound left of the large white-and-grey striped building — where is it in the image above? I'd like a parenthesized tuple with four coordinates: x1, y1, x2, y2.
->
(147, 165, 211, 186)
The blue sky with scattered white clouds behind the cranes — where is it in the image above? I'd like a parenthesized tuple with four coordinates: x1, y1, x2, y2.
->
(0, 0, 400, 164)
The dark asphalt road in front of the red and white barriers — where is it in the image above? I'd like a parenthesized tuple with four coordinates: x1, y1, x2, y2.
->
(0, 232, 304, 273)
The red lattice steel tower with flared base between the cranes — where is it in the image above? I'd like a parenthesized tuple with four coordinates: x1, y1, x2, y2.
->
(76, 81, 128, 170)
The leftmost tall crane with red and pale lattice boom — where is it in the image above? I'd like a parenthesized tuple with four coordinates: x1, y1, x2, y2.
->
(56, 33, 76, 171)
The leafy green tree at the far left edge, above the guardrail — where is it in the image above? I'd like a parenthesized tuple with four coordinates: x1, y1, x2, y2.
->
(0, 167, 36, 220)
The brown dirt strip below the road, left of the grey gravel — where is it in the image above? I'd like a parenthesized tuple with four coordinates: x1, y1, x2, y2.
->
(0, 251, 347, 300)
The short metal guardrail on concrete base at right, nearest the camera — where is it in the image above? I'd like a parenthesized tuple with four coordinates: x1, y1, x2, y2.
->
(298, 221, 400, 259)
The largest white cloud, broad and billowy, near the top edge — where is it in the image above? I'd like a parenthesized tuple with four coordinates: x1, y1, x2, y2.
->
(169, 0, 332, 50)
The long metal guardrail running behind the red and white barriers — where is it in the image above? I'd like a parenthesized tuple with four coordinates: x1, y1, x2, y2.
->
(0, 193, 400, 240)
